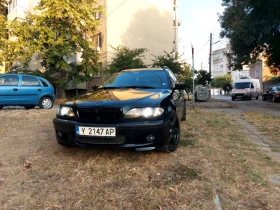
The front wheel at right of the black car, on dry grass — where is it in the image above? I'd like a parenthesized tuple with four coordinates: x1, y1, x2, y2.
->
(162, 111, 180, 153)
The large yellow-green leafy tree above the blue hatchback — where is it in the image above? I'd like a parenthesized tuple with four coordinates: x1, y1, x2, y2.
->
(2, 0, 102, 92)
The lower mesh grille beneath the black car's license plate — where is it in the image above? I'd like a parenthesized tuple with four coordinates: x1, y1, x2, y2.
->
(76, 136, 125, 145)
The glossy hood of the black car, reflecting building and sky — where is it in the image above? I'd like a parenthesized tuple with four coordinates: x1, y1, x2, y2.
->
(65, 89, 171, 107)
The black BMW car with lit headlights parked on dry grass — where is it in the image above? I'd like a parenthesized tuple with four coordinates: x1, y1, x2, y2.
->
(53, 68, 186, 152)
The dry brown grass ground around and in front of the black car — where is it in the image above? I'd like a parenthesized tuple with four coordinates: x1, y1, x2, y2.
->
(0, 109, 280, 210)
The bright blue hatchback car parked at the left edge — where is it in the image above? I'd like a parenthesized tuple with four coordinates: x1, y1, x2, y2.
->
(0, 74, 55, 109)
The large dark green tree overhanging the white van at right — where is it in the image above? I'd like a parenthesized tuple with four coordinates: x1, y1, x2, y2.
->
(219, 0, 280, 74)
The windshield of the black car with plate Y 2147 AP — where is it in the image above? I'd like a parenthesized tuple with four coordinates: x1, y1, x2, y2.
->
(103, 70, 169, 89)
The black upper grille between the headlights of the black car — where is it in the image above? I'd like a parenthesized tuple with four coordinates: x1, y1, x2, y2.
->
(77, 108, 123, 122)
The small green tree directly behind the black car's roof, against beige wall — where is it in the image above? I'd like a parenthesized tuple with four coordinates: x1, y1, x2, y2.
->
(105, 45, 148, 74)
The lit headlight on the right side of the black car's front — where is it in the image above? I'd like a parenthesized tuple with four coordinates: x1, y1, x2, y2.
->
(125, 107, 164, 118)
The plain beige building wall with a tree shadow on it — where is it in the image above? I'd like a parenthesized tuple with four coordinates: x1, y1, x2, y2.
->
(97, 0, 175, 67)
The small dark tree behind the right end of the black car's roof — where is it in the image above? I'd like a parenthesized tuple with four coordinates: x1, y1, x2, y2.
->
(152, 51, 182, 74)
